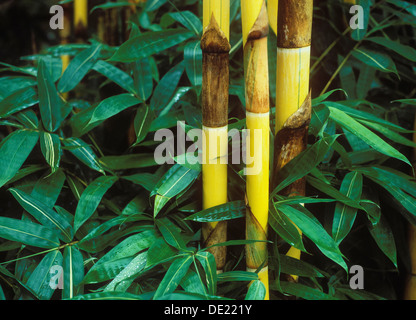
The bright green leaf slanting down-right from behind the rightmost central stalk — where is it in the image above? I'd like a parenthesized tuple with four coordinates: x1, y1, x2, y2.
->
(276, 205, 348, 272)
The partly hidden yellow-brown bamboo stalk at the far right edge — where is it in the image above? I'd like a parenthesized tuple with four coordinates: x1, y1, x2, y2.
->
(403, 114, 416, 300)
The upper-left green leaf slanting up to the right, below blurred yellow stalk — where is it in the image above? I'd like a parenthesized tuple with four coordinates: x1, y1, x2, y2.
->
(58, 44, 102, 92)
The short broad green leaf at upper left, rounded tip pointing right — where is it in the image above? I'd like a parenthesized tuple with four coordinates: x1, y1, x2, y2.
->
(88, 93, 140, 125)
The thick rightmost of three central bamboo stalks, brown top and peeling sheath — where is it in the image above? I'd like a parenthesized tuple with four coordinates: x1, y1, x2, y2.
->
(274, 0, 313, 281)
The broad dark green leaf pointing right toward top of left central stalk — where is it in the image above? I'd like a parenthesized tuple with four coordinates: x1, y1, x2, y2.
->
(110, 29, 193, 62)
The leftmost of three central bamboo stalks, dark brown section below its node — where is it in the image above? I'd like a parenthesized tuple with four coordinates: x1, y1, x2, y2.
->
(201, 0, 231, 273)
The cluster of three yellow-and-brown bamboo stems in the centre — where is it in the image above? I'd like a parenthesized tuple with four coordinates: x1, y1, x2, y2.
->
(201, 0, 313, 300)
